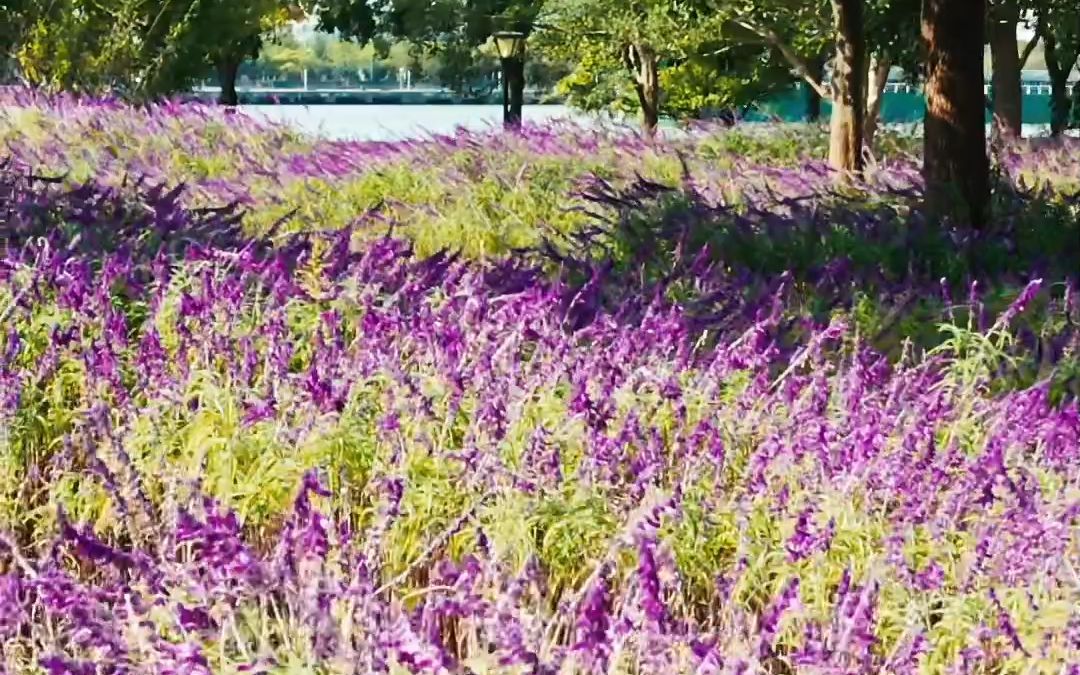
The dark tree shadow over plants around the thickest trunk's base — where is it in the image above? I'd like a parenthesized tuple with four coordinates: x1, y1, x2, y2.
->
(523, 166, 1080, 394)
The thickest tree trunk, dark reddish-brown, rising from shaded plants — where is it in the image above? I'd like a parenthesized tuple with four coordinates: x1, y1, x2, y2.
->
(922, 0, 989, 228)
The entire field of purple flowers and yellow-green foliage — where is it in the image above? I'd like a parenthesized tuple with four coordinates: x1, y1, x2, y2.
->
(0, 92, 1080, 675)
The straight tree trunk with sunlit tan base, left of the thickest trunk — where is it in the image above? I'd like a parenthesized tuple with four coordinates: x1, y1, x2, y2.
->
(828, 0, 866, 173)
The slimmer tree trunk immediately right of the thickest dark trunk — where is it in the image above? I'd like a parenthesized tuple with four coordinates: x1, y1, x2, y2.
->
(988, 0, 1024, 138)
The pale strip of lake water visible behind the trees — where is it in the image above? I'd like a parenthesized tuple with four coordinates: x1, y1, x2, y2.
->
(243, 105, 1050, 140)
